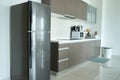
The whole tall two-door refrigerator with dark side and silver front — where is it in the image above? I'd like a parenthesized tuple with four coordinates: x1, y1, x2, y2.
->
(10, 1, 50, 80)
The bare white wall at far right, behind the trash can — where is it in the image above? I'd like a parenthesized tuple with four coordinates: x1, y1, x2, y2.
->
(102, 0, 120, 55)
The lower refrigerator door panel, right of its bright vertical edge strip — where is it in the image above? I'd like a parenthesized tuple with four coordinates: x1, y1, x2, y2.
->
(33, 32, 50, 80)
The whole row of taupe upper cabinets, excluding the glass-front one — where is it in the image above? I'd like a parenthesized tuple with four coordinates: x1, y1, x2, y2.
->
(51, 0, 87, 20)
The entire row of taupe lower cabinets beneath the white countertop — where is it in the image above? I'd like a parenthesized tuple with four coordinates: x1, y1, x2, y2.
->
(51, 40, 101, 72)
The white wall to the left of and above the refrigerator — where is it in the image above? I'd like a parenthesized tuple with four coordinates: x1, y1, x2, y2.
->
(0, 0, 41, 80)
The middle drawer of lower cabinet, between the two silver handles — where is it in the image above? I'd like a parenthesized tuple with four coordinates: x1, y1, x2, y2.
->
(59, 47, 69, 60)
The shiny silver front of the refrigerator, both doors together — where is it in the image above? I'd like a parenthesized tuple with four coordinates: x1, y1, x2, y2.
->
(28, 2, 50, 80)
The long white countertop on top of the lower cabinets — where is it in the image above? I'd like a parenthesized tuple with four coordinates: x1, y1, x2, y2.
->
(51, 39, 101, 44)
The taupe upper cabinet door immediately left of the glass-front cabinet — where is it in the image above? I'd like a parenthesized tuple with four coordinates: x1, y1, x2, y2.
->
(75, 0, 87, 20)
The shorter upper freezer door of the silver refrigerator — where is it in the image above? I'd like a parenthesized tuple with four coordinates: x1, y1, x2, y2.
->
(28, 2, 51, 31)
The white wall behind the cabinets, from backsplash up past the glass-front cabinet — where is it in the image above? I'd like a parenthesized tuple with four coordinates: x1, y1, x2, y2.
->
(51, 0, 102, 39)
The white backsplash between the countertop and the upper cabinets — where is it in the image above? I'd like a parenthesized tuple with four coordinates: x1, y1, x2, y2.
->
(51, 13, 101, 39)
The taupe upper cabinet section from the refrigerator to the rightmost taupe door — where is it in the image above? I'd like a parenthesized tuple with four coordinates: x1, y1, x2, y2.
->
(51, 0, 75, 16)
